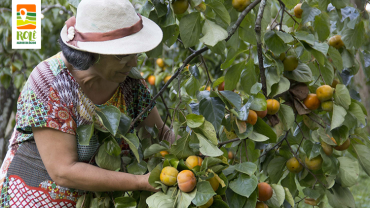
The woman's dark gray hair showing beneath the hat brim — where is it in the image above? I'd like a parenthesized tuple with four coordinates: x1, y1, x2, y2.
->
(58, 38, 97, 70)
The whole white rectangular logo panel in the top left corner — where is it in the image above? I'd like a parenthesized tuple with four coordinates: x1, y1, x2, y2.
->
(12, 0, 41, 49)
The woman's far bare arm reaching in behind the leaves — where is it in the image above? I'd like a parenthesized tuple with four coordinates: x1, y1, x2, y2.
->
(138, 107, 175, 144)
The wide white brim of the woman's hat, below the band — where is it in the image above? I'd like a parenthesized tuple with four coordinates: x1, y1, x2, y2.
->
(60, 17, 163, 55)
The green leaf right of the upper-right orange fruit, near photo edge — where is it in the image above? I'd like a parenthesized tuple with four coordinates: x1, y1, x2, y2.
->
(342, 21, 365, 48)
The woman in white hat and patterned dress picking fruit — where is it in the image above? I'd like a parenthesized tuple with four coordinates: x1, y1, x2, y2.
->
(0, 0, 173, 207)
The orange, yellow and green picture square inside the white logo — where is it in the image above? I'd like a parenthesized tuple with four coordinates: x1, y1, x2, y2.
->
(17, 4, 36, 30)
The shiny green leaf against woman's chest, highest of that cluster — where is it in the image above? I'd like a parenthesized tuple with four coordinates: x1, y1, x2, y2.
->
(96, 106, 121, 135)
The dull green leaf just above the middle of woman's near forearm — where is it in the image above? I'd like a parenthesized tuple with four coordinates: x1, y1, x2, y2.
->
(95, 146, 121, 171)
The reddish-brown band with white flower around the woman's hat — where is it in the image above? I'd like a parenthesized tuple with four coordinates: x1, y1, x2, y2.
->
(66, 14, 143, 48)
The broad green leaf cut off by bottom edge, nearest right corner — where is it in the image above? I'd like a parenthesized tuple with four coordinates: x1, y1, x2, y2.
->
(326, 183, 355, 208)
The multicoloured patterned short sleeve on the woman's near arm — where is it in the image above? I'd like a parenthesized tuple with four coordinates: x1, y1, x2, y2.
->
(16, 62, 77, 135)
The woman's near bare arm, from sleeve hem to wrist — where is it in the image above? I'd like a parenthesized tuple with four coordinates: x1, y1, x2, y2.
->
(32, 128, 158, 191)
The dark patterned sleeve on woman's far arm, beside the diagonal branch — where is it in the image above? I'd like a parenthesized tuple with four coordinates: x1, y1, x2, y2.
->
(133, 79, 156, 127)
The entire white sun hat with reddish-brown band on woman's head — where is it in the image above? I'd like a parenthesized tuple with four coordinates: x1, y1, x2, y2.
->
(60, 0, 163, 55)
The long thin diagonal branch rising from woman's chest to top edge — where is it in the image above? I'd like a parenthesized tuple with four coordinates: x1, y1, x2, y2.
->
(130, 0, 261, 129)
